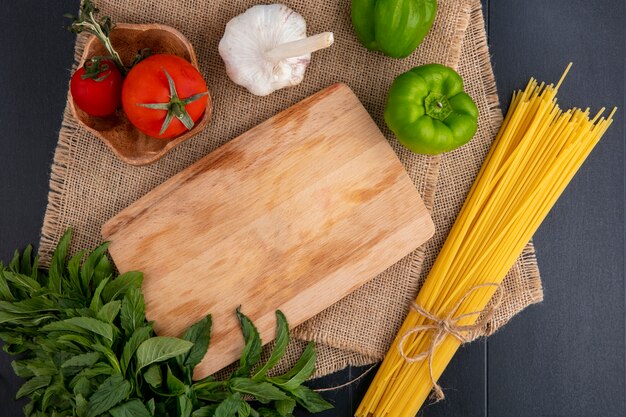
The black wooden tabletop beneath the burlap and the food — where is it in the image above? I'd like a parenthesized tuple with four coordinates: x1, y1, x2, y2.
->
(0, 0, 626, 417)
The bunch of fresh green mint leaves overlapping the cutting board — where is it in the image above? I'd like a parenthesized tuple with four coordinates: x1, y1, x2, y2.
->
(0, 230, 332, 417)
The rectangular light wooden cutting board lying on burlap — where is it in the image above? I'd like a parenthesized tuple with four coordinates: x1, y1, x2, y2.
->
(102, 84, 434, 378)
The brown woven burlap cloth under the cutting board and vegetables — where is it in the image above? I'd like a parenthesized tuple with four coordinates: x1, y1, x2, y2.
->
(40, 0, 542, 376)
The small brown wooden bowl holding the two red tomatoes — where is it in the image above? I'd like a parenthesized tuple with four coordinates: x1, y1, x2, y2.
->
(69, 23, 213, 165)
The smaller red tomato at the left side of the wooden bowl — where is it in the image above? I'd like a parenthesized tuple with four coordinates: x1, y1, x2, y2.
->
(70, 59, 122, 117)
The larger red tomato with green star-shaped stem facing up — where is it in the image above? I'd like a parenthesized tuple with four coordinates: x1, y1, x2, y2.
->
(122, 55, 208, 139)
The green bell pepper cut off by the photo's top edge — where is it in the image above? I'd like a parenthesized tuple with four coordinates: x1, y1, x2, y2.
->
(352, 0, 437, 58)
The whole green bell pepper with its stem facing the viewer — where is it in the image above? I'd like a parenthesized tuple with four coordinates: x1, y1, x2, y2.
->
(385, 64, 478, 155)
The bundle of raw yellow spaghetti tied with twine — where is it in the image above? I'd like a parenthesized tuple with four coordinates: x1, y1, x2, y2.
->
(356, 64, 615, 417)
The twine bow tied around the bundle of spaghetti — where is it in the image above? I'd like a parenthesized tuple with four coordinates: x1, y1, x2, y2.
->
(398, 282, 503, 402)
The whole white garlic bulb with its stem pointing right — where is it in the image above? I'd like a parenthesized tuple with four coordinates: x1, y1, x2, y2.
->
(219, 4, 333, 96)
